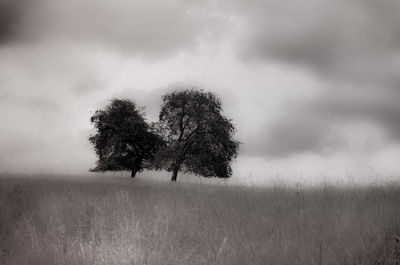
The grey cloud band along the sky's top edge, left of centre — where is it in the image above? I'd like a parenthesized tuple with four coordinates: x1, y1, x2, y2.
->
(0, 0, 224, 58)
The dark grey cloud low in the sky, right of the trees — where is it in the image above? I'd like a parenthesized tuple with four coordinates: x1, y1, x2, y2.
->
(244, 84, 400, 158)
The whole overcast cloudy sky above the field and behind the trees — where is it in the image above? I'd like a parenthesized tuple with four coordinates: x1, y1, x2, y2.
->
(0, 0, 400, 182)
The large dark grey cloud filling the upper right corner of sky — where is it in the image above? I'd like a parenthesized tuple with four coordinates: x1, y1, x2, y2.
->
(227, 0, 400, 86)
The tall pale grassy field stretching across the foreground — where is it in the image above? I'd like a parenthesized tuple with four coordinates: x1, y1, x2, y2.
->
(0, 173, 400, 265)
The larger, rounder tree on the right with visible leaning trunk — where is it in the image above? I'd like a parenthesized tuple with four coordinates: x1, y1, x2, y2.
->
(153, 88, 239, 181)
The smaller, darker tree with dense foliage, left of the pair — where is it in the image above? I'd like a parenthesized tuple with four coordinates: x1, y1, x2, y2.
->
(89, 99, 163, 177)
